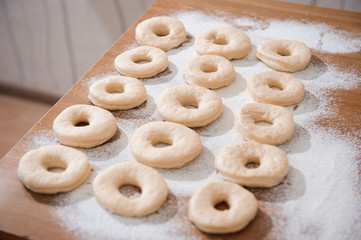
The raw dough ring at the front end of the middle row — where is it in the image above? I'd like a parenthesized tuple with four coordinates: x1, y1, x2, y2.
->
(93, 162, 168, 217)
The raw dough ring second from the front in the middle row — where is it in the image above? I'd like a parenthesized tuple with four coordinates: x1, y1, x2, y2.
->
(130, 122, 202, 168)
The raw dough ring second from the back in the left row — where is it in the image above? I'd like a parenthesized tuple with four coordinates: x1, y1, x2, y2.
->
(114, 46, 168, 78)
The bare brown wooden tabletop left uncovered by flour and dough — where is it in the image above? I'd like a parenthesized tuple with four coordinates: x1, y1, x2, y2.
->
(0, 0, 361, 239)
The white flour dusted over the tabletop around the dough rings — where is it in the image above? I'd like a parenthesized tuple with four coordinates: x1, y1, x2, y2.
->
(28, 12, 361, 239)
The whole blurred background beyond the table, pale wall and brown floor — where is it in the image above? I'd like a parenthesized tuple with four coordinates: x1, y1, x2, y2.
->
(0, 0, 361, 158)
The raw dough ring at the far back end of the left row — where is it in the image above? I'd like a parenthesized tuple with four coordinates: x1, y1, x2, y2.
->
(135, 16, 187, 51)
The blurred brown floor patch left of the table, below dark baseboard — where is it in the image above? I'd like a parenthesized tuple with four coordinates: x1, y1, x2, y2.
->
(0, 94, 51, 159)
